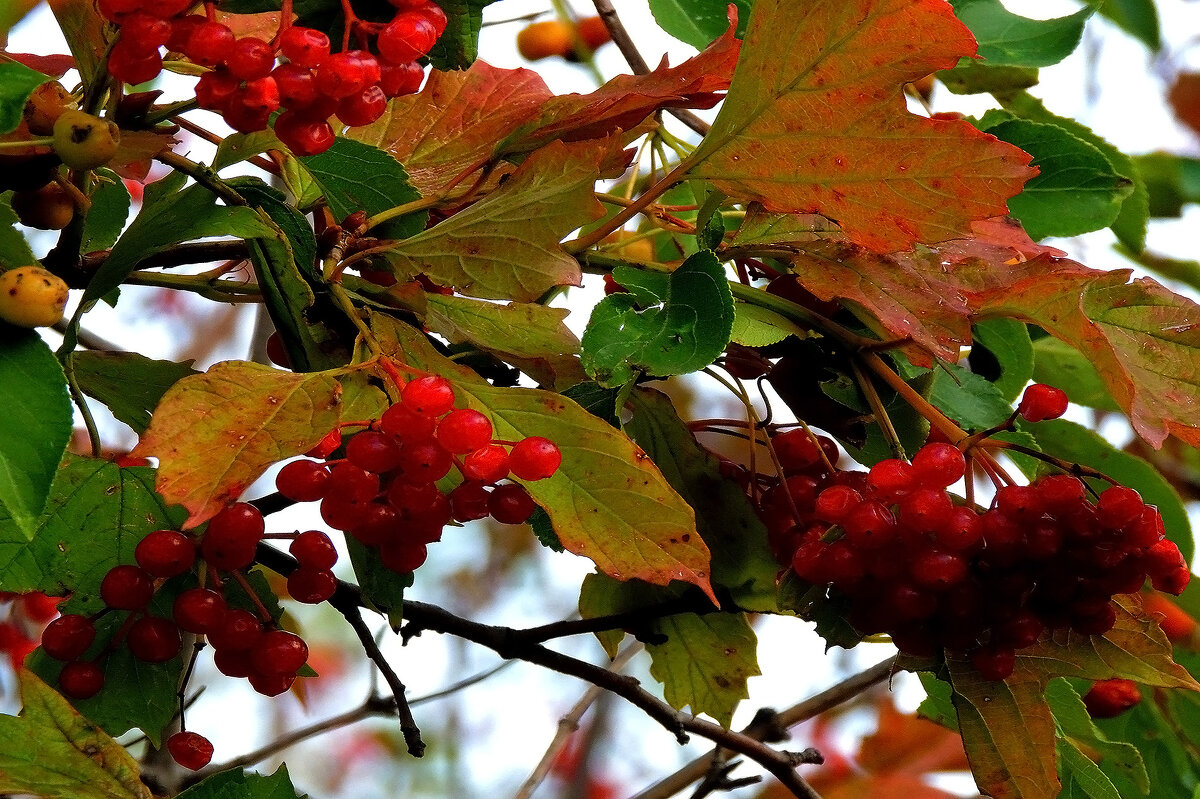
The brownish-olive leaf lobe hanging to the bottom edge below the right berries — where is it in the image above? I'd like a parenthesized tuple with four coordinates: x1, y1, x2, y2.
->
(947, 657, 1060, 799)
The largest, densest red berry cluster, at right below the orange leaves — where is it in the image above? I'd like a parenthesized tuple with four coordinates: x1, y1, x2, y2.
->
(761, 429, 1190, 679)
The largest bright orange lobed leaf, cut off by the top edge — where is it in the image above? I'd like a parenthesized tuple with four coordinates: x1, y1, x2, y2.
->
(691, 0, 1036, 252)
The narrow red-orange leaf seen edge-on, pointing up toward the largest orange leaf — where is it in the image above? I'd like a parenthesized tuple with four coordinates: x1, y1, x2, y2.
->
(498, 28, 742, 152)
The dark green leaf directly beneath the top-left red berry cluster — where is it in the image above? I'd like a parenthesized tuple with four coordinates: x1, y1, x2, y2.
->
(300, 137, 430, 239)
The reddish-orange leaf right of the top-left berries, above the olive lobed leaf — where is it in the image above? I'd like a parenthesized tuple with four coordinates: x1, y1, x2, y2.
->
(348, 61, 553, 197)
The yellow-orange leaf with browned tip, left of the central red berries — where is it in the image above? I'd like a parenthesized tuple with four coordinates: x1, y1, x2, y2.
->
(130, 361, 342, 528)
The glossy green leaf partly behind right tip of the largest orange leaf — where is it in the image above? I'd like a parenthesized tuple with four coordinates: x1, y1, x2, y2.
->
(986, 119, 1133, 240)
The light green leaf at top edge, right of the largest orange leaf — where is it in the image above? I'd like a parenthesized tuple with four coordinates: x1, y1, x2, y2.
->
(950, 0, 1096, 67)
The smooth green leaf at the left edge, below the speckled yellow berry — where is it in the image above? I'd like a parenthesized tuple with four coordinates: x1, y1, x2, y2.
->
(0, 323, 73, 533)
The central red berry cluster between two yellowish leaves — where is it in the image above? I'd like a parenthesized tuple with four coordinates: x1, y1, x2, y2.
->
(276, 376, 562, 577)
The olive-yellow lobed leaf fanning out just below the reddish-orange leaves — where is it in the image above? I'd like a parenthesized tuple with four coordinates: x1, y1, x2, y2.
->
(374, 139, 614, 302)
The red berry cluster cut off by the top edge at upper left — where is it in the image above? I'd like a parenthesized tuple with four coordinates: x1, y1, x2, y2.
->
(98, 0, 446, 156)
